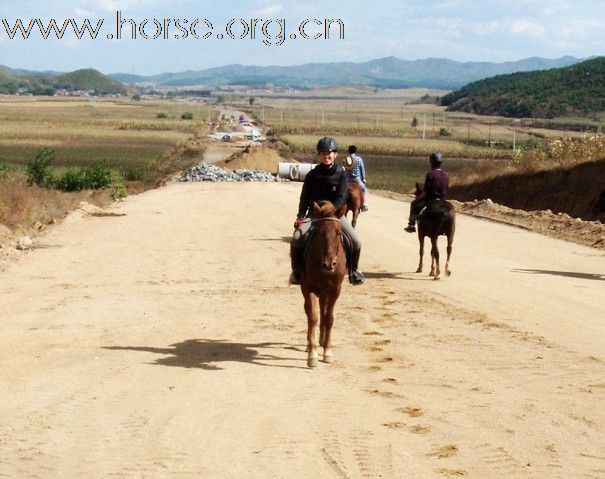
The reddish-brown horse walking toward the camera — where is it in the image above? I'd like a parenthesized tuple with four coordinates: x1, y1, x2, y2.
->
(300, 201, 347, 368)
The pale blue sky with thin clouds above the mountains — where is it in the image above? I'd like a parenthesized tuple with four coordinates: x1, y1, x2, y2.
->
(0, 0, 605, 74)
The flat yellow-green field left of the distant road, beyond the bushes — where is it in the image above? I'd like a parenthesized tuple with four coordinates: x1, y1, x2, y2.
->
(0, 96, 210, 169)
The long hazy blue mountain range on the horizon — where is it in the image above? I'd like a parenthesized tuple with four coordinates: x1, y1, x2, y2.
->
(109, 56, 580, 90)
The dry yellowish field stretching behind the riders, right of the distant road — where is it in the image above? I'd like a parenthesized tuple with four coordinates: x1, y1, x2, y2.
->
(231, 89, 600, 192)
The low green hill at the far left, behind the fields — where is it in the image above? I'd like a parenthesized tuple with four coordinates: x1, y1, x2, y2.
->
(0, 65, 129, 95)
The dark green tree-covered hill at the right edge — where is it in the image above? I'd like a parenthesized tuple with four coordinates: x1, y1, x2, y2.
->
(441, 57, 605, 118)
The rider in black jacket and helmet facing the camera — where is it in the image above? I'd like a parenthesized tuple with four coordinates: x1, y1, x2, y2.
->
(290, 137, 364, 284)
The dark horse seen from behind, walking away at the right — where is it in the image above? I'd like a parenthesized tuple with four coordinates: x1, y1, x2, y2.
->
(415, 183, 456, 279)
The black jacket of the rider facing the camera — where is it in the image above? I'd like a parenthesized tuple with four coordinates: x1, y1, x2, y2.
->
(298, 163, 349, 218)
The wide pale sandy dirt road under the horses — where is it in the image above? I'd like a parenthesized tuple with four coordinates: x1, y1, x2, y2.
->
(0, 183, 605, 478)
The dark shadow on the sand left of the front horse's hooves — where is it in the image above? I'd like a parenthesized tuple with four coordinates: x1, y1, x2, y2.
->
(103, 339, 306, 371)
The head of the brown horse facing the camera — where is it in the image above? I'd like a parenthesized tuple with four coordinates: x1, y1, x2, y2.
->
(312, 201, 344, 273)
